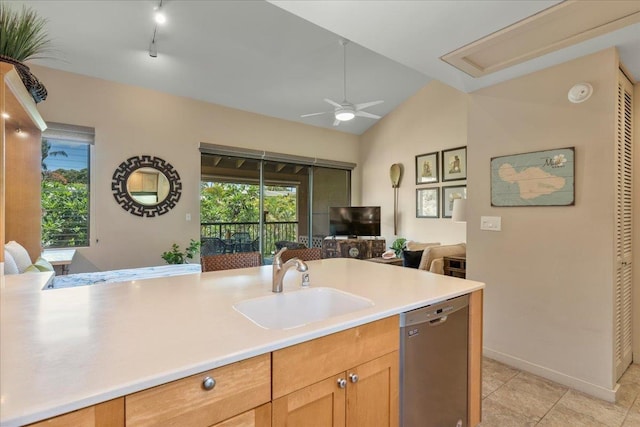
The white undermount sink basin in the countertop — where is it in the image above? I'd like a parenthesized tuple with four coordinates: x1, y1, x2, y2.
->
(233, 287, 373, 329)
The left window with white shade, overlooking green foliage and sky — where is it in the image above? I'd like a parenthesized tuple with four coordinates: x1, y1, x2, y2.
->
(41, 123, 94, 248)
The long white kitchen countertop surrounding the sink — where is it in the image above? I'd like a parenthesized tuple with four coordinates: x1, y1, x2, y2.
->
(0, 258, 484, 427)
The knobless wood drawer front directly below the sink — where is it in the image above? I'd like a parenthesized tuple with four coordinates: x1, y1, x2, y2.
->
(272, 316, 400, 399)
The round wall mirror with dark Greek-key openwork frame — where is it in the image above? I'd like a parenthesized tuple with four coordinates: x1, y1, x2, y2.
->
(111, 156, 182, 217)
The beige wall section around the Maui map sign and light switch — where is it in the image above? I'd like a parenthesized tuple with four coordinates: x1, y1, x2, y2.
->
(467, 49, 618, 399)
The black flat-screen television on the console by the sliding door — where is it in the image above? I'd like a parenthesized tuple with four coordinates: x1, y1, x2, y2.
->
(329, 206, 380, 237)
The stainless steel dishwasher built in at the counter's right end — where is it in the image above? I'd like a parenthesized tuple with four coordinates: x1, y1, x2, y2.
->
(400, 295, 469, 427)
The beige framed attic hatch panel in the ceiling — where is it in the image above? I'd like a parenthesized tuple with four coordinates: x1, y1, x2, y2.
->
(440, 0, 640, 77)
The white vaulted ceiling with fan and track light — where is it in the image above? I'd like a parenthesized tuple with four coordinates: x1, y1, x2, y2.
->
(11, 0, 640, 134)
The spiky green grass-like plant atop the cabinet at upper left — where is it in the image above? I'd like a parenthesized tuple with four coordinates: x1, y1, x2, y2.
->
(0, 2, 51, 102)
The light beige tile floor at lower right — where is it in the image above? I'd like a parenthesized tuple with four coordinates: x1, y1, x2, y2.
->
(480, 358, 640, 427)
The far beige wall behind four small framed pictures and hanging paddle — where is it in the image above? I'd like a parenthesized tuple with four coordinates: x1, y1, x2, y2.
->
(360, 80, 468, 246)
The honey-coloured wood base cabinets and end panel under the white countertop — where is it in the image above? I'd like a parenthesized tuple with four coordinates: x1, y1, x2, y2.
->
(21, 298, 483, 427)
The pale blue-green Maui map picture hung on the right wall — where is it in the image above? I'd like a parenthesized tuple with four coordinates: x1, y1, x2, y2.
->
(491, 147, 575, 206)
